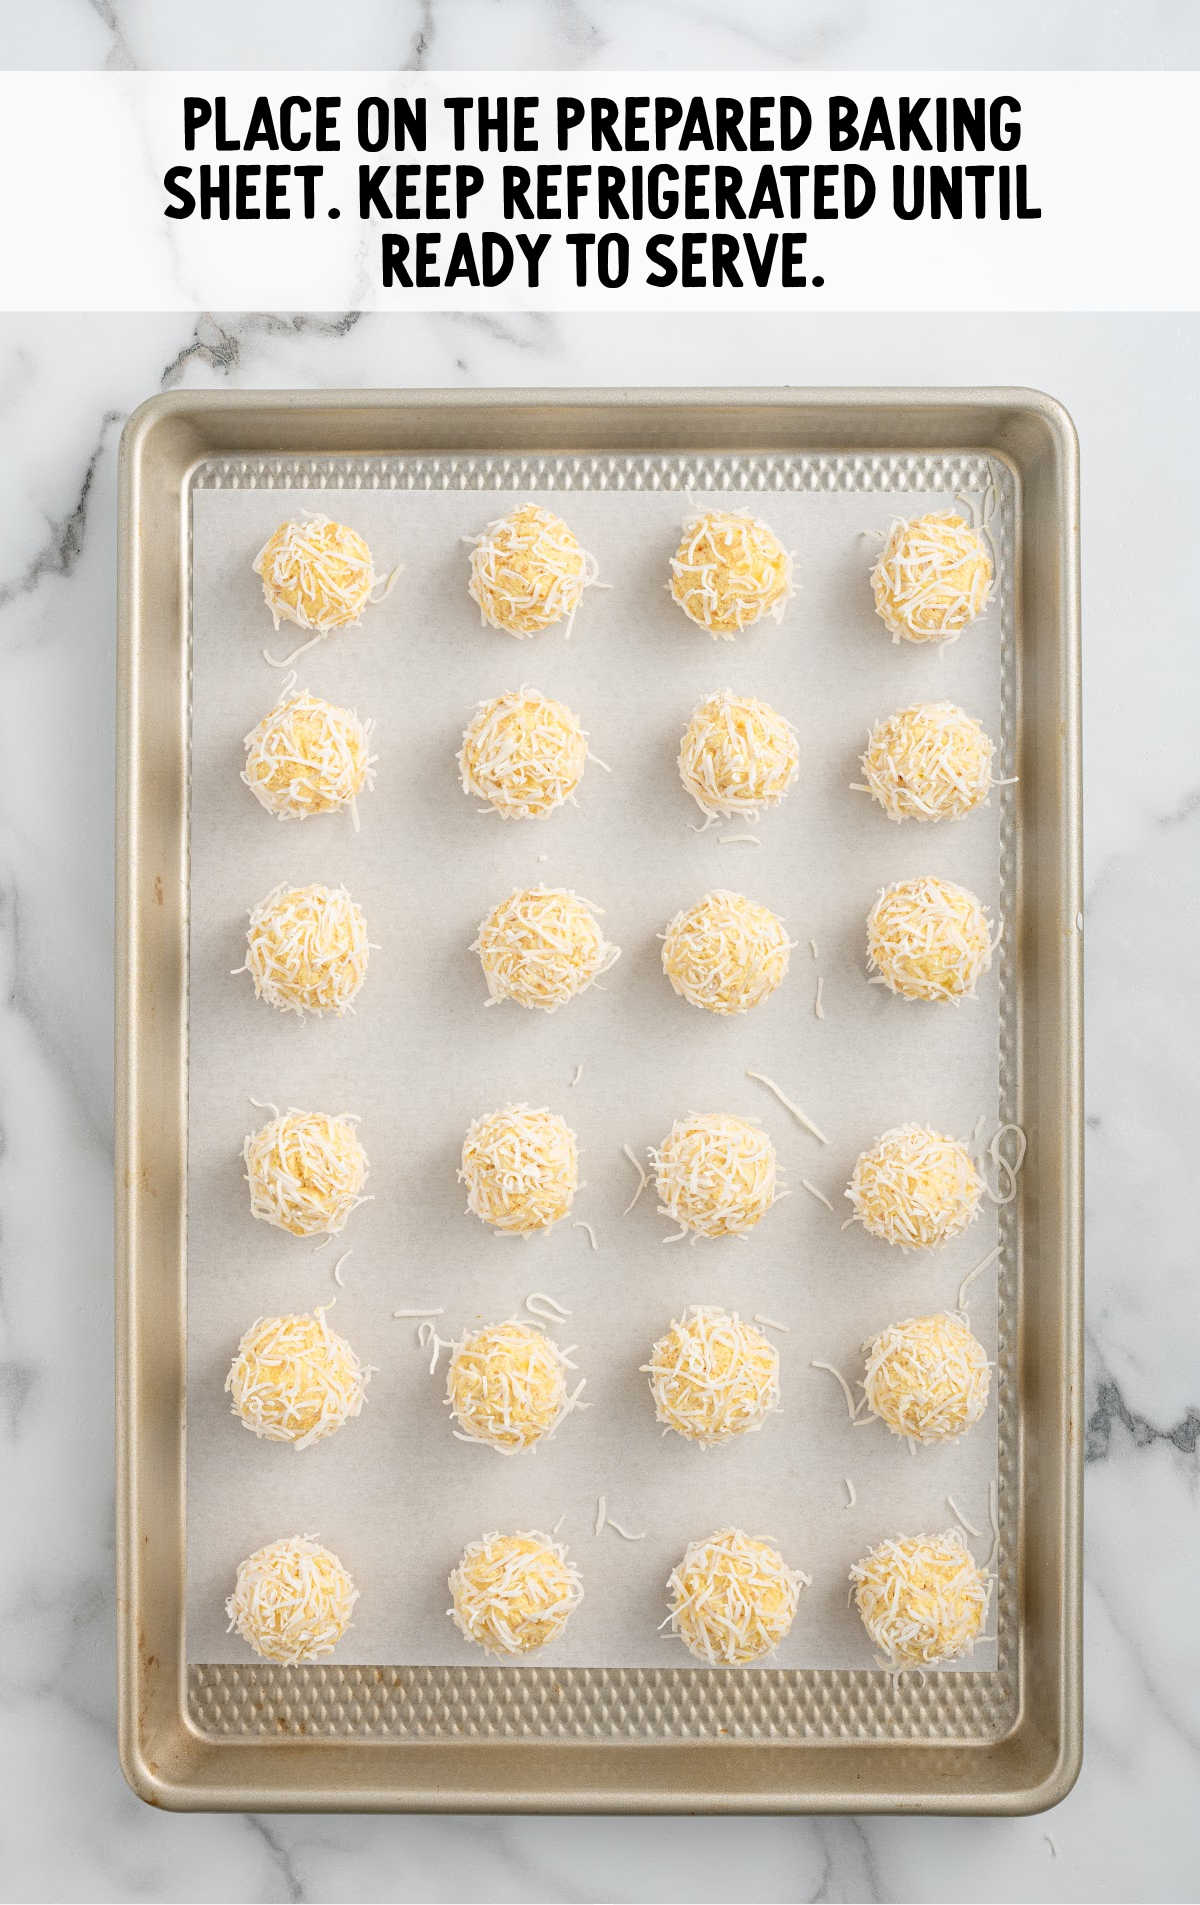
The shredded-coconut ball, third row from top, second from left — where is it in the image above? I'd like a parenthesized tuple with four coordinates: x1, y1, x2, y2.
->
(470, 886, 621, 1012)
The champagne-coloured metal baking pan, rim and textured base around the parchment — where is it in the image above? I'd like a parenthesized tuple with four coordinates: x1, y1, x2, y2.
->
(118, 392, 1080, 1810)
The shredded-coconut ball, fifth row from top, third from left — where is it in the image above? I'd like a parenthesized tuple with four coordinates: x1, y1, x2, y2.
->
(644, 1305, 779, 1448)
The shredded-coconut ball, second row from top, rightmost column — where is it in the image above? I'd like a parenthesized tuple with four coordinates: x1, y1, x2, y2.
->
(861, 701, 996, 821)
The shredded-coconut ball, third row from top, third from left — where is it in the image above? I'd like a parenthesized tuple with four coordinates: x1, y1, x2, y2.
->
(663, 890, 792, 1015)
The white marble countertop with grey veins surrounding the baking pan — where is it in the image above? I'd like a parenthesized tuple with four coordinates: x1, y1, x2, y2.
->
(0, 0, 1200, 1901)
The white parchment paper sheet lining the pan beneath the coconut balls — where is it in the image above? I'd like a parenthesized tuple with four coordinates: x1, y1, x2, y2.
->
(187, 459, 1010, 1669)
